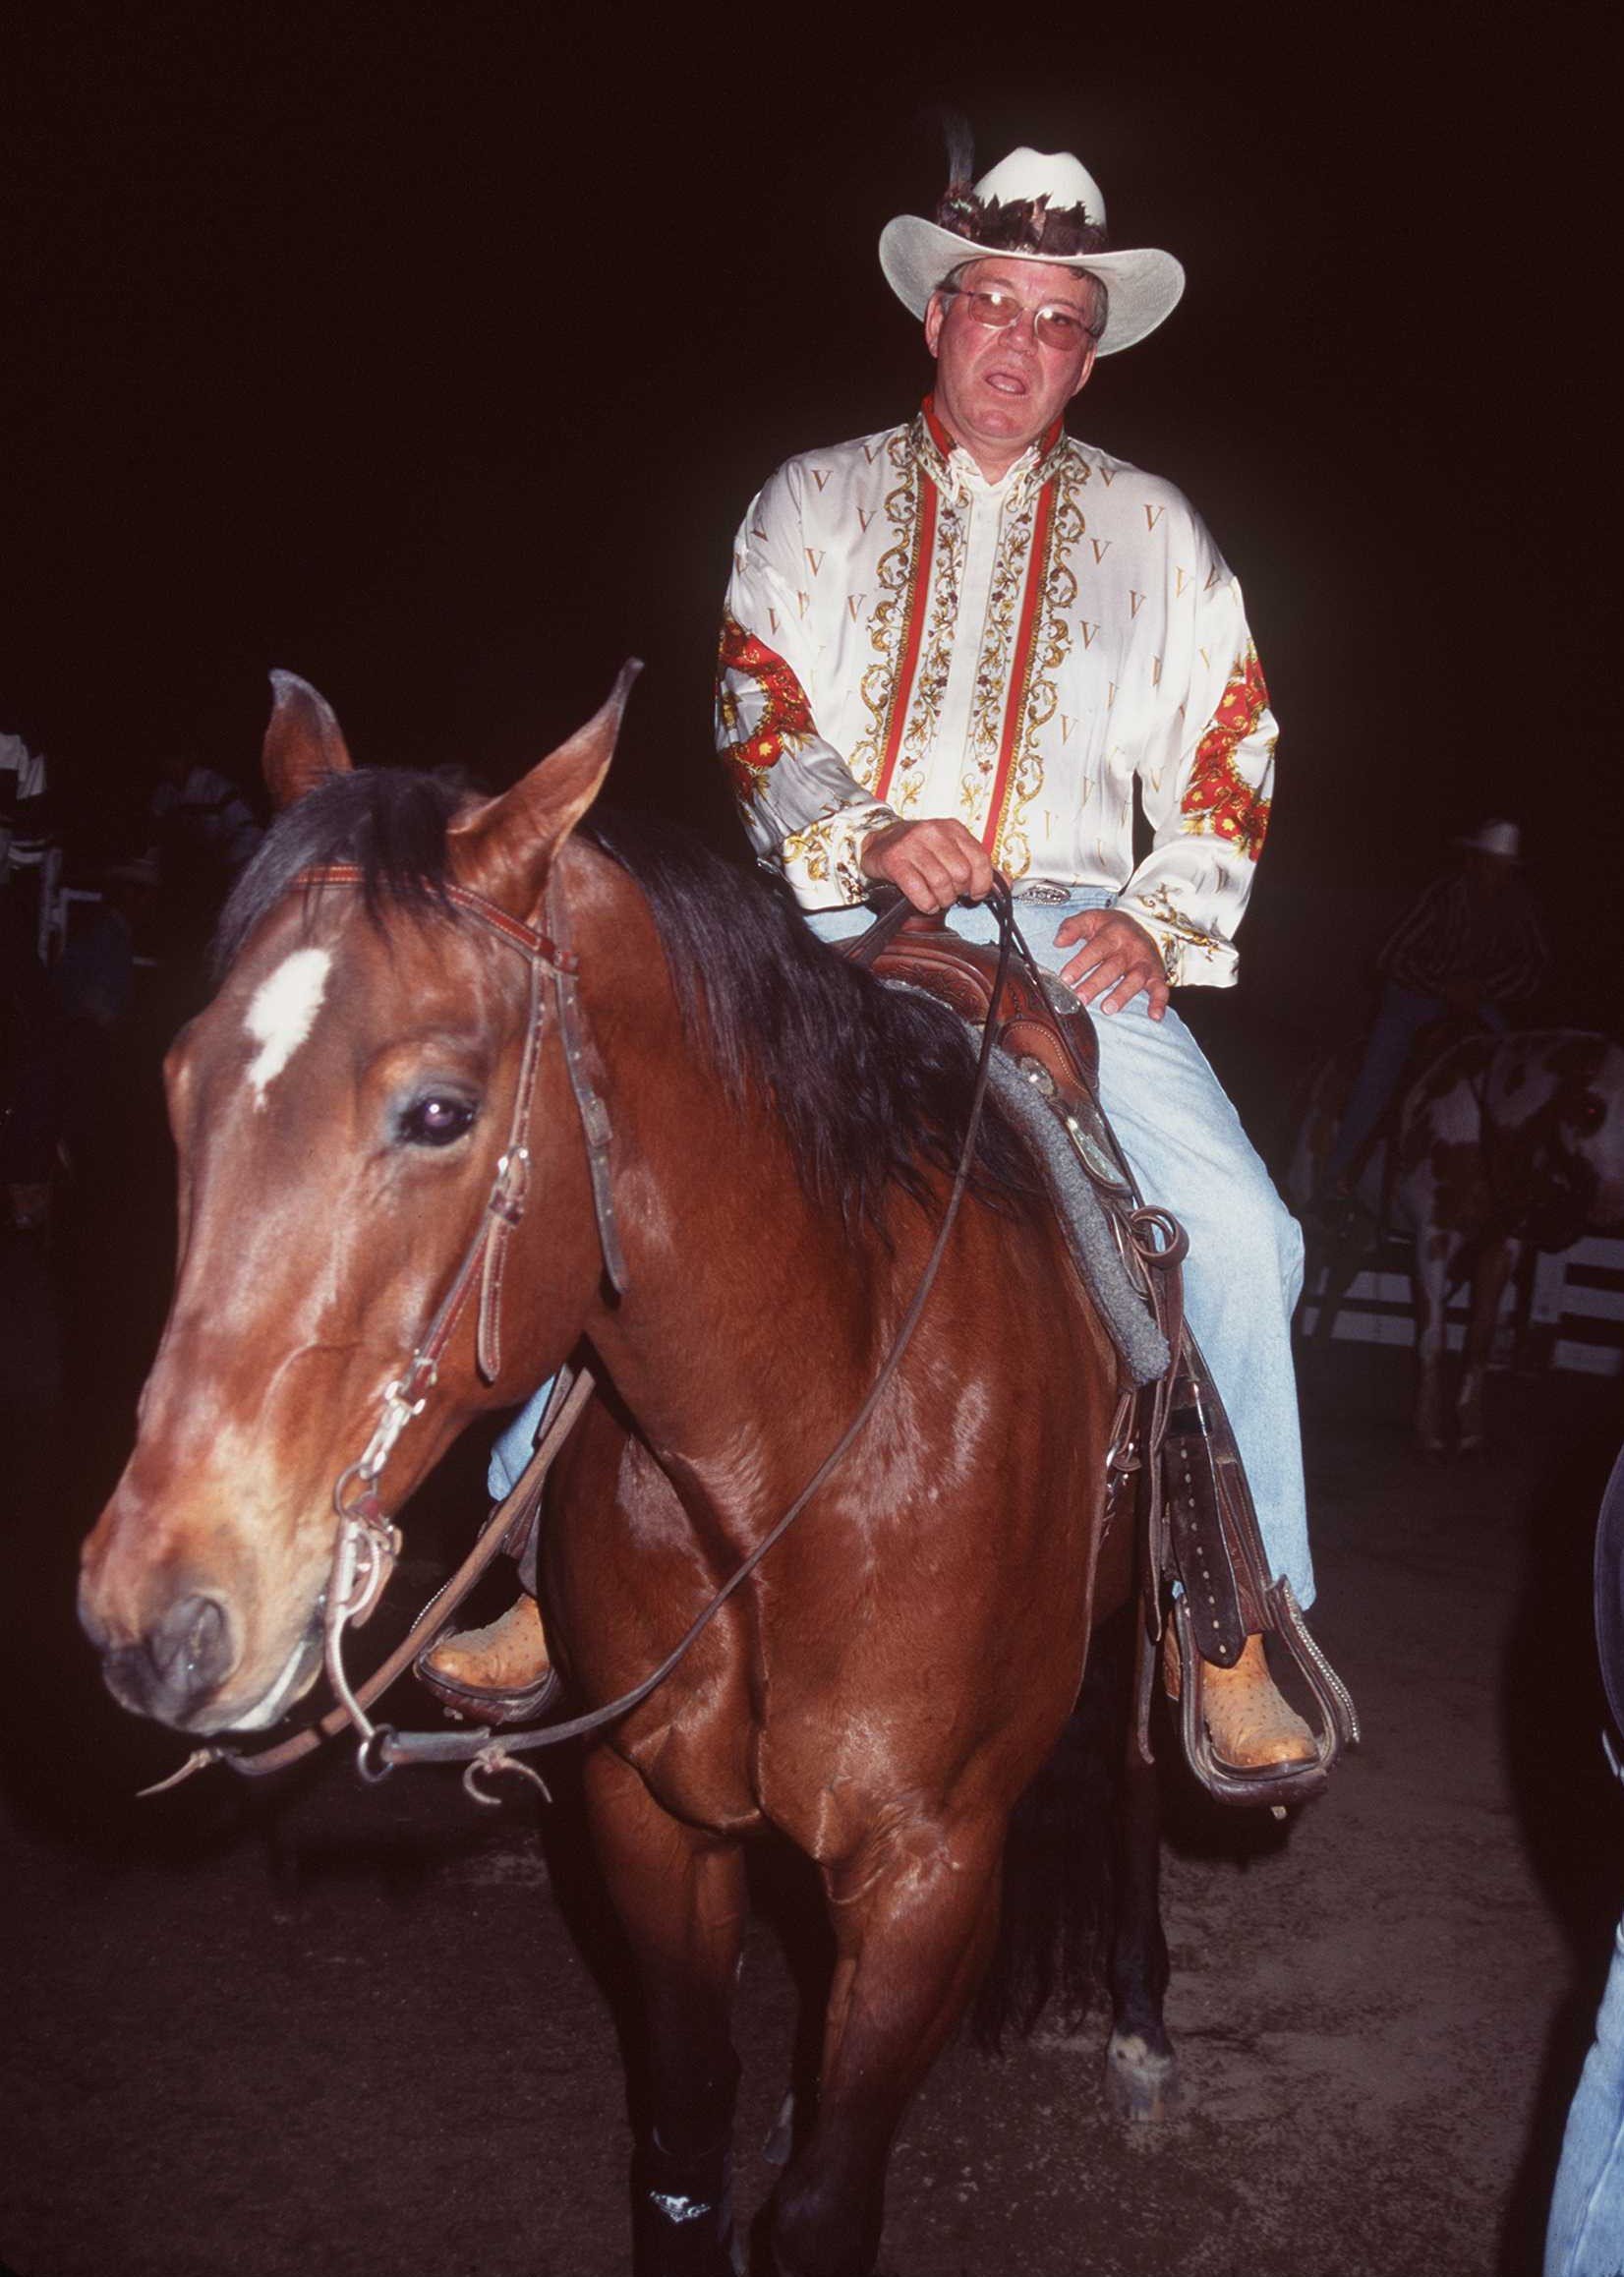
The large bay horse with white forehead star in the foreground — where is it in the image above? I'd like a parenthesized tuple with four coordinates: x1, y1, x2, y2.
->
(80, 668, 1171, 2277)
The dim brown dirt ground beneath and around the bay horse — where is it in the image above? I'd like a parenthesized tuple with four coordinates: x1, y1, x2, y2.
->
(0, 1042, 1624, 2277)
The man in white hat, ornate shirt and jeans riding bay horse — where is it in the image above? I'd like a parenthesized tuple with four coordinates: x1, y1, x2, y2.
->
(429, 138, 1314, 1772)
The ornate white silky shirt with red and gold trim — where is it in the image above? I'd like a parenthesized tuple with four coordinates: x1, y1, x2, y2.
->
(718, 401, 1276, 986)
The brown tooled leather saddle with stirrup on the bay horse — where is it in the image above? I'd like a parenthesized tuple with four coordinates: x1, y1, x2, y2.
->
(845, 898, 1358, 1806)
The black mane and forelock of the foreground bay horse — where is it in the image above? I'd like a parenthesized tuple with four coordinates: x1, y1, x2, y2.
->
(214, 767, 1034, 1225)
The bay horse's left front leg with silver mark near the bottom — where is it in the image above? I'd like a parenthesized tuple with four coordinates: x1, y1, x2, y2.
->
(585, 1749, 745, 2277)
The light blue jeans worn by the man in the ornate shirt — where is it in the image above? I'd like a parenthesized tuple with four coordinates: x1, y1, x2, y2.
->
(490, 888, 1314, 1607)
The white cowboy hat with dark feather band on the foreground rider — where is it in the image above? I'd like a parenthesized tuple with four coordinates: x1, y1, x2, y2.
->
(879, 146, 1185, 355)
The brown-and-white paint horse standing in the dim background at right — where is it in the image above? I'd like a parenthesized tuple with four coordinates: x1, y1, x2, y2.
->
(1289, 1029, 1624, 1455)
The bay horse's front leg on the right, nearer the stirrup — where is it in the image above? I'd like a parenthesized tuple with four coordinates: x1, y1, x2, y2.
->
(772, 1815, 1005, 2277)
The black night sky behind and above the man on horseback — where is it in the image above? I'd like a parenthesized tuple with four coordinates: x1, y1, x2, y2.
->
(0, 5, 1624, 1040)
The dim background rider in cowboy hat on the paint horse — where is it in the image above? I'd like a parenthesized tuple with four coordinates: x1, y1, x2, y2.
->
(1319, 822, 1551, 1216)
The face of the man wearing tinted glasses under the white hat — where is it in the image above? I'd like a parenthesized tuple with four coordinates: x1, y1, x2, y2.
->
(925, 253, 1093, 481)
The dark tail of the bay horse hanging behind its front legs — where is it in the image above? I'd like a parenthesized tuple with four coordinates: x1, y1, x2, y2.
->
(970, 1603, 1136, 2047)
